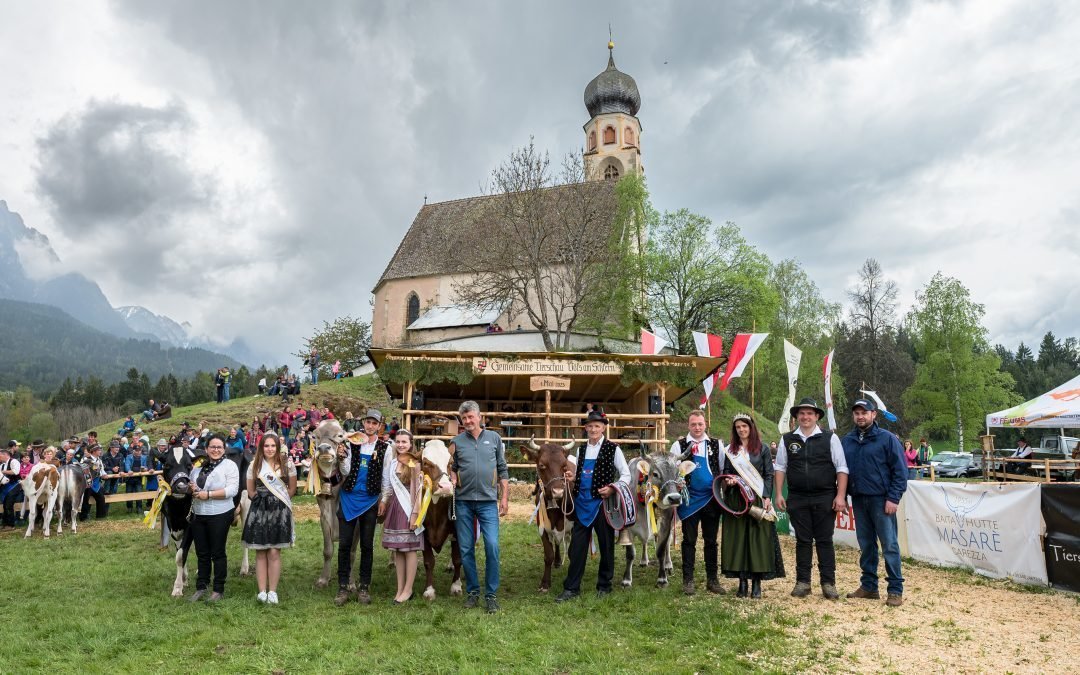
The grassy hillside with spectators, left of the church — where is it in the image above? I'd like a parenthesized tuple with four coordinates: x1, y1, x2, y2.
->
(87, 375, 401, 442)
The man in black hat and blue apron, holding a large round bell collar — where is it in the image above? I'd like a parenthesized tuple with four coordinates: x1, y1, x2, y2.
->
(555, 410, 630, 603)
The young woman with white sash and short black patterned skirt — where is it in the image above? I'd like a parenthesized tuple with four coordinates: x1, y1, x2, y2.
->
(241, 433, 296, 605)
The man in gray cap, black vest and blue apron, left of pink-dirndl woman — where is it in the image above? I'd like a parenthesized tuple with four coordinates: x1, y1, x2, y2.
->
(336, 408, 388, 607)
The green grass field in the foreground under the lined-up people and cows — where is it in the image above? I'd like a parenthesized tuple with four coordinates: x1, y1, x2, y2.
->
(0, 501, 826, 673)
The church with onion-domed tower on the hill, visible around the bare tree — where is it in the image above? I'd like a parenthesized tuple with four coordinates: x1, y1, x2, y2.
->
(372, 42, 645, 352)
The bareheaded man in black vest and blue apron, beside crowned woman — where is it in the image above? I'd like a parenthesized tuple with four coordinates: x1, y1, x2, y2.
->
(672, 410, 724, 595)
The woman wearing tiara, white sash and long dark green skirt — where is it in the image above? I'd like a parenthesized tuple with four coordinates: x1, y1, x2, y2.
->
(720, 413, 784, 598)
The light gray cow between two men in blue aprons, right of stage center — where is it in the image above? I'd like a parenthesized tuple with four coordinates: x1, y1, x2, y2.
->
(622, 451, 693, 588)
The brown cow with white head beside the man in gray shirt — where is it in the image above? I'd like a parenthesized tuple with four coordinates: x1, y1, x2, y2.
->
(421, 441, 461, 600)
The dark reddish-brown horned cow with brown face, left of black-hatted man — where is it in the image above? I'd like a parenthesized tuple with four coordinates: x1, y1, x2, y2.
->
(522, 438, 576, 593)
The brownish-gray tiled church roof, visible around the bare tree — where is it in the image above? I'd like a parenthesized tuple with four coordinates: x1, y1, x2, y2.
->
(375, 180, 616, 288)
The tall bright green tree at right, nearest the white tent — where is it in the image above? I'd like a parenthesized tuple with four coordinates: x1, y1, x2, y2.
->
(904, 272, 1020, 449)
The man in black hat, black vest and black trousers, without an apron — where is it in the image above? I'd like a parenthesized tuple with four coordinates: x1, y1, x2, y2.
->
(775, 399, 848, 600)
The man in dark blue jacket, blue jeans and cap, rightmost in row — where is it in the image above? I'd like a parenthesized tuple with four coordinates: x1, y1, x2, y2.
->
(841, 399, 907, 607)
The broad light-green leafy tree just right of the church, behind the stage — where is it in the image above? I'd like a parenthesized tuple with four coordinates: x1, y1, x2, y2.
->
(646, 208, 778, 353)
